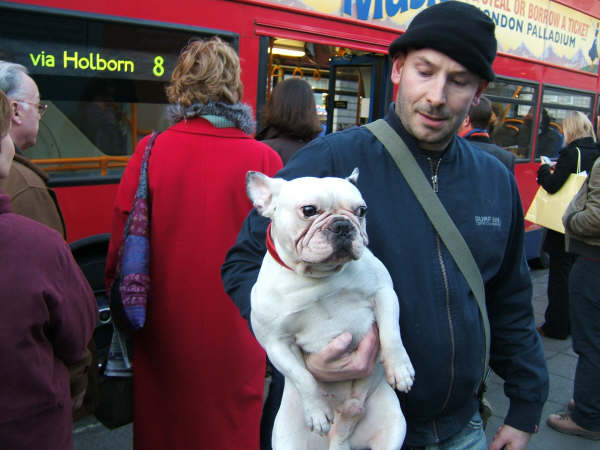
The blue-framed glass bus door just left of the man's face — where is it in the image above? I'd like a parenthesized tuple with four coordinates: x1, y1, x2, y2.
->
(326, 54, 392, 133)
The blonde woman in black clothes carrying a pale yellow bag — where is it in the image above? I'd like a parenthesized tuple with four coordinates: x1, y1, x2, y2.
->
(537, 111, 599, 339)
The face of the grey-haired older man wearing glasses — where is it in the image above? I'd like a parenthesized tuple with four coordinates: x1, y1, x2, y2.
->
(10, 74, 42, 150)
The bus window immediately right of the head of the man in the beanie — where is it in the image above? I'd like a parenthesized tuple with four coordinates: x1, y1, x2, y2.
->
(485, 79, 538, 161)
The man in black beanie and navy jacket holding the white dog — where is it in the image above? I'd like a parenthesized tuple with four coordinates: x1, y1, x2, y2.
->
(222, 1, 548, 450)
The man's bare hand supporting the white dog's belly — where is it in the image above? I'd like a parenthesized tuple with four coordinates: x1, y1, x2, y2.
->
(305, 324, 379, 382)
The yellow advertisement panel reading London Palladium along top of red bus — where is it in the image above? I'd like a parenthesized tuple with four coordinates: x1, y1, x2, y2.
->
(268, 0, 600, 74)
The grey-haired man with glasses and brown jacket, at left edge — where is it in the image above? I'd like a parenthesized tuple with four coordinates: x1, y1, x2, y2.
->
(0, 61, 67, 239)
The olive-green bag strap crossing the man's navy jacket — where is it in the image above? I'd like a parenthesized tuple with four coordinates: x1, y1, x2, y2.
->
(365, 119, 490, 388)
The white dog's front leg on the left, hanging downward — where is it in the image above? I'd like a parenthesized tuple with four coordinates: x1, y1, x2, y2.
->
(265, 339, 333, 434)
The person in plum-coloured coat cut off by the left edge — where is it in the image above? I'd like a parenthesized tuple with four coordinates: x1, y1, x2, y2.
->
(0, 91, 97, 450)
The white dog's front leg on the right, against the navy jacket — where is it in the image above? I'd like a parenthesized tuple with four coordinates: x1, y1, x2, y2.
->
(374, 286, 415, 392)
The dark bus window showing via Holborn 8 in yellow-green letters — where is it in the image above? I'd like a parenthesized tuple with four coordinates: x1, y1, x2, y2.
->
(0, 9, 237, 179)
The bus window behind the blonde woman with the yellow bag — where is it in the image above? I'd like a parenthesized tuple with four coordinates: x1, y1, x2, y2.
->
(535, 86, 594, 159)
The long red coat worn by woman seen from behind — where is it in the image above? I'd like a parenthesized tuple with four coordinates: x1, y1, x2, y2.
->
(107, 119, 282, 450)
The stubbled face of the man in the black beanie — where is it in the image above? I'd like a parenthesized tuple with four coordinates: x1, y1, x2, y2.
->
(392, 49, 488, 150)
